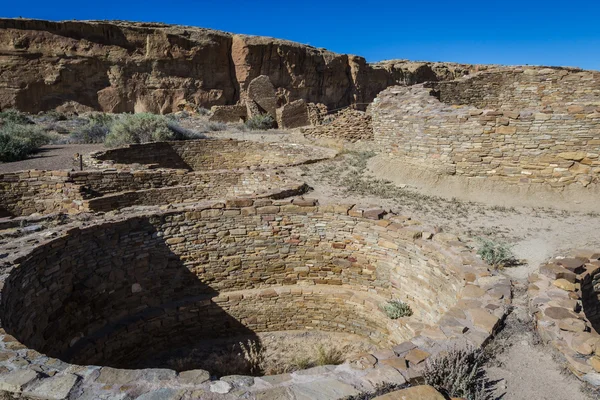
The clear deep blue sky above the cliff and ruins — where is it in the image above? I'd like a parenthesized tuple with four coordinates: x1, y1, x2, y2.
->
(0, 0, 600, 70)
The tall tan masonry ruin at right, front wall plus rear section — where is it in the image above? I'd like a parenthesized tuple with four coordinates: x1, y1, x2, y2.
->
(371, 69, 600, 188)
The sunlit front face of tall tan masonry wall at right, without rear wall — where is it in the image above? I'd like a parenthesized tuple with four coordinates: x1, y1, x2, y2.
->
(371, 83, 600, 188)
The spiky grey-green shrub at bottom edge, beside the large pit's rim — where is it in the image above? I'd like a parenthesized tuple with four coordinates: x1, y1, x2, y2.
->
(423, 348, 493, 400)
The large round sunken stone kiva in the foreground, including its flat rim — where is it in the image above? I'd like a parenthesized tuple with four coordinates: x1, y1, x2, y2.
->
(0, 199, 511, 398)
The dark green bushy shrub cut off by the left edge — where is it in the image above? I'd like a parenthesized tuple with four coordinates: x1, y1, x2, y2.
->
(0, 122, 50, 162)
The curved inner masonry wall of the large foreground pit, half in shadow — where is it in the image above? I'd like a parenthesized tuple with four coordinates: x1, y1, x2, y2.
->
(2, 200, 464, 365)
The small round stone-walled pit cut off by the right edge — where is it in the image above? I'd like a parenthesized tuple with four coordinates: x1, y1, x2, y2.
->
(528, 250, 600, 387)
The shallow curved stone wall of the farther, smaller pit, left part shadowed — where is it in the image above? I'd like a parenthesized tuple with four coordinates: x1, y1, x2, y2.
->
(85, 139, 336, 171)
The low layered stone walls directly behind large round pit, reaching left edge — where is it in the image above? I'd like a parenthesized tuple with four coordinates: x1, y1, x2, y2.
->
(0, 169, 306, 216)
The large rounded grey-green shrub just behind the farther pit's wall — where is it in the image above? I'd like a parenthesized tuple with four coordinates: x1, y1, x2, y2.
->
(104, 113, 175, 147)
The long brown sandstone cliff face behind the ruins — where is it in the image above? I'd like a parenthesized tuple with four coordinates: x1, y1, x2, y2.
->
(0, 19, 473, 113)
